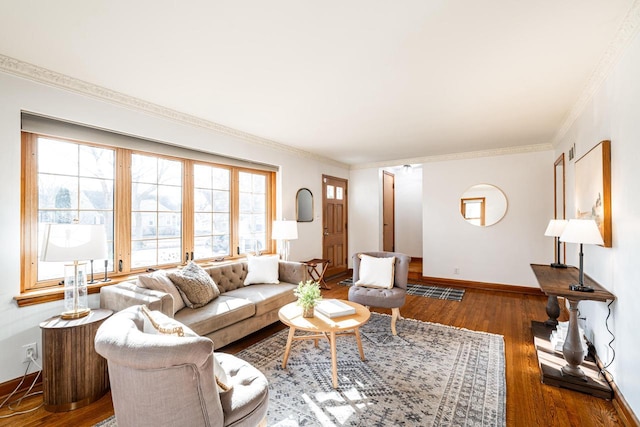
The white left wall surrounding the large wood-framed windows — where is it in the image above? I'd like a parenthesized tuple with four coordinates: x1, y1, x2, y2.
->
(0, 73, 349, 382)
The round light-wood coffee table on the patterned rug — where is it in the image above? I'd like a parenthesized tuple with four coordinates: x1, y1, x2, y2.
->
(278, 300, 371, 388)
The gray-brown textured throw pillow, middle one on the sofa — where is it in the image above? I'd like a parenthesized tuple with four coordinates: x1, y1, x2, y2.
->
(167, 262, 220, 308)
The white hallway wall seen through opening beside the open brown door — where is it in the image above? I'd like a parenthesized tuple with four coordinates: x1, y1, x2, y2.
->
(395, 167, 422, 258)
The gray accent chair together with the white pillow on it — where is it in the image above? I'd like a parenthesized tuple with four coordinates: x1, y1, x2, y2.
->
(349, 252, 411, 335)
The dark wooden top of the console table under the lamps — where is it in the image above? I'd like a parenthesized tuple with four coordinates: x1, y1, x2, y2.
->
(531, 264, 616, 301)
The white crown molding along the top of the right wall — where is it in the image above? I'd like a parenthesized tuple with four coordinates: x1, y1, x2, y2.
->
(552, 0, 640, 147)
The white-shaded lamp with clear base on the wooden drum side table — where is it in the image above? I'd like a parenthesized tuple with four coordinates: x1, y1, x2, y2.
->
(40, 223, 108, 320)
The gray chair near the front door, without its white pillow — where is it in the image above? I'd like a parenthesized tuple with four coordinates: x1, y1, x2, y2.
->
(349, 252, 411, 335)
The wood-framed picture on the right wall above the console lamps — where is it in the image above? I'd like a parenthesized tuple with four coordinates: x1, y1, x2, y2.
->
(575, 141, 611, 248)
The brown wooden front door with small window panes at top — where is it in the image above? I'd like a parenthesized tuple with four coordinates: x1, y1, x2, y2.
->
(322, 175, 348, 277)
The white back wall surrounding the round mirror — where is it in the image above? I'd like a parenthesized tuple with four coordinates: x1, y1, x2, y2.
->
(422, 151, 554, 287)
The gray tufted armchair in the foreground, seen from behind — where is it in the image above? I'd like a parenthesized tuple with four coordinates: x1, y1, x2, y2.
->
(95, 306, 269, 427)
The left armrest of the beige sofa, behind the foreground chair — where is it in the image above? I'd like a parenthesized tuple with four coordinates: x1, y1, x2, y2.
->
(100, 282, 173, 317)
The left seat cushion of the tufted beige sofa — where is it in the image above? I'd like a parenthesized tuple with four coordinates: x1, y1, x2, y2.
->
(175, 294, 256, 344)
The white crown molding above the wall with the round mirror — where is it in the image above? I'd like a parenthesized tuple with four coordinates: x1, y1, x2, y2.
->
(351, 143, 553, 170)
